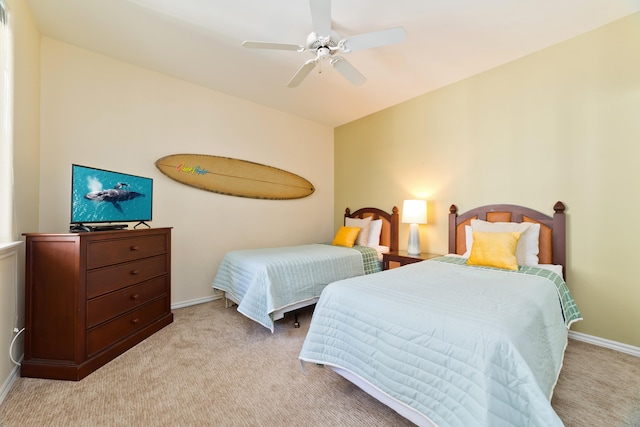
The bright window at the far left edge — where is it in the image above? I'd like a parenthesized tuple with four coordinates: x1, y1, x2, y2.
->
(0, 0, 16, 245)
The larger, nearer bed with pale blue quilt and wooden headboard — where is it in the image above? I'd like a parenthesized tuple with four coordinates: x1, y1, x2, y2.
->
(300, 202, 581, 427)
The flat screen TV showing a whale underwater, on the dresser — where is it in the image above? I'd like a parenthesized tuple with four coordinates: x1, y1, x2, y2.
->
(71, 165, 153, 231)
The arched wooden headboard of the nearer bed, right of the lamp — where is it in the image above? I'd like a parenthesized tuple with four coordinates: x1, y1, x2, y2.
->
(449, 202, 567, 276)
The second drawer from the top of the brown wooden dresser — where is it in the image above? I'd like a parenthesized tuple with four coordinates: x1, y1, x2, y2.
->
(87, 255, 167, 299)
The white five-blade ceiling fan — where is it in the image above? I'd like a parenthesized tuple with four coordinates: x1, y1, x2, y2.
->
(242, 0, 407, 88)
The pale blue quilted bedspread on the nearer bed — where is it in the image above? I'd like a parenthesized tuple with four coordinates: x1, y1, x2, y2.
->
(300, 260, 579, 427)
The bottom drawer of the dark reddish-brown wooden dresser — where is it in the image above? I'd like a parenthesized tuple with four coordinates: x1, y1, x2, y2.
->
(87, 299, 167, 357)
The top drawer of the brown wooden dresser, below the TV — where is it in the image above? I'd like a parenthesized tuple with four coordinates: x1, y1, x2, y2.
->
(87, 234, 168, 269)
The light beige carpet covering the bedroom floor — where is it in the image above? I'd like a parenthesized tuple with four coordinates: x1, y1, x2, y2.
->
(0, 301, 640, 427)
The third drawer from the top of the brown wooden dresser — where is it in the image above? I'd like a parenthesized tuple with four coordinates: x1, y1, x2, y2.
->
(87, 275, 167, 328)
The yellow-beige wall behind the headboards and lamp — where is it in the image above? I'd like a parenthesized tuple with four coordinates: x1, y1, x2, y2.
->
(334, 14, 640, 346)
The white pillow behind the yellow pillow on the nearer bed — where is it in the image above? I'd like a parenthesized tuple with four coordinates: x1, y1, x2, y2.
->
(465, 219, 540, 266)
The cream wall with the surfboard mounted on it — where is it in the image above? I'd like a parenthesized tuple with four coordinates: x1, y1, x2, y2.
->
(38, 38, 334, 305)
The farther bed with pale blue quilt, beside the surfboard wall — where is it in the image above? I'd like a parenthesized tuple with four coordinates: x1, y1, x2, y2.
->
(212, 206, 398, 332)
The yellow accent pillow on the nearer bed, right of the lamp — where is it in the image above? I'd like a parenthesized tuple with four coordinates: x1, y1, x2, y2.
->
(467, 231, 522, 270)
